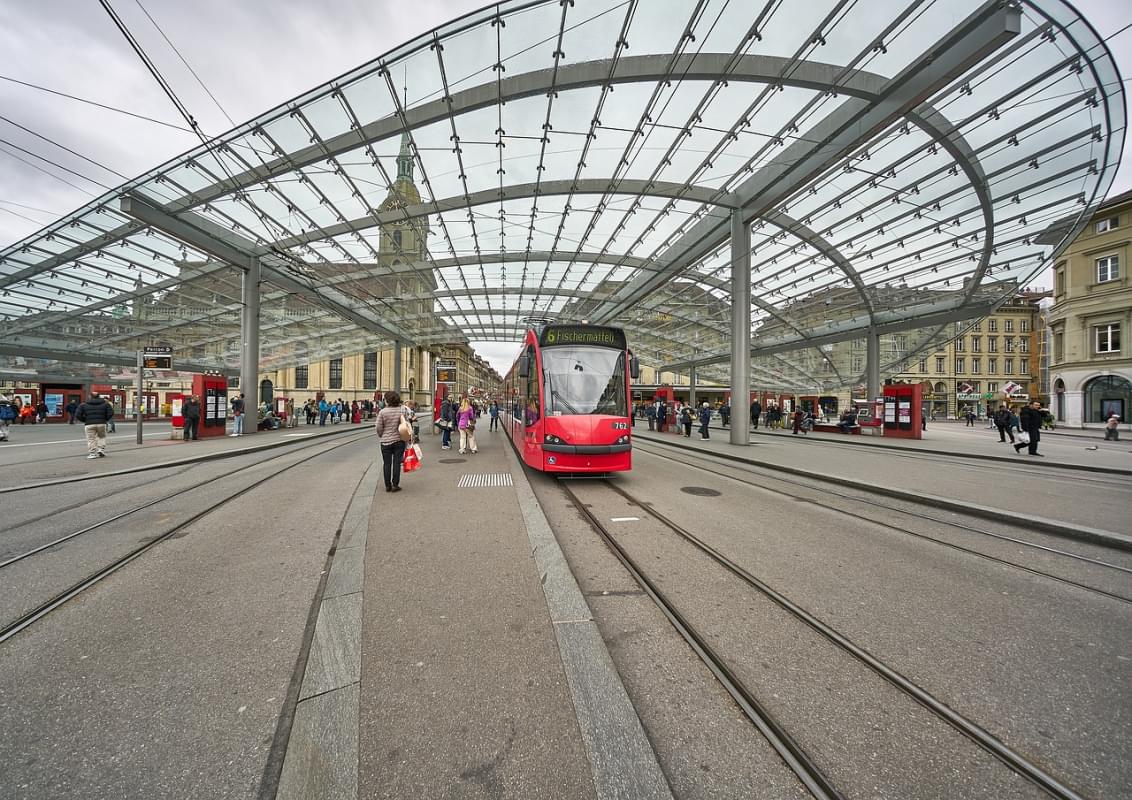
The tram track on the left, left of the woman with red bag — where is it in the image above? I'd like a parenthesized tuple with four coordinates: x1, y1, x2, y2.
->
(0, 431, 368, 645)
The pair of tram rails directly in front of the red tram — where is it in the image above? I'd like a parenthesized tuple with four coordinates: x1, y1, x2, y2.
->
(559, 481, 1081, 800)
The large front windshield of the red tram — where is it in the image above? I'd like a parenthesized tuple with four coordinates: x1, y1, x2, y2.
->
(542, 347, 628, 416)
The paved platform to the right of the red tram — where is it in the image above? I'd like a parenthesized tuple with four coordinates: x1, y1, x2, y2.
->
(635, 424, 1132, 548)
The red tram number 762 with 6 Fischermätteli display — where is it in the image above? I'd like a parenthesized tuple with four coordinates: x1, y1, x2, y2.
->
(499, 325, 640, 473)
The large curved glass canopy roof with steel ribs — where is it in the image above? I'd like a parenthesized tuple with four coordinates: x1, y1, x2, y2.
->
(0, 0, 1125, 386)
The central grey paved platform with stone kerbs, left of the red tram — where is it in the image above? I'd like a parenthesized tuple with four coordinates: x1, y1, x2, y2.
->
(271, 427, 670, 799)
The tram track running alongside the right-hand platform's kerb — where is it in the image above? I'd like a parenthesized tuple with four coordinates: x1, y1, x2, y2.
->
(636, 440, 1132, 603)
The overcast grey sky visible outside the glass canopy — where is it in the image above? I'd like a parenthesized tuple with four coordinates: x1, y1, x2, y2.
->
(0, 0, 1132, 371)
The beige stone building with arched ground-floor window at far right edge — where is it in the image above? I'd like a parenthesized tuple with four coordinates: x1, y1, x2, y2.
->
(1048, 192, 1132, 430)
